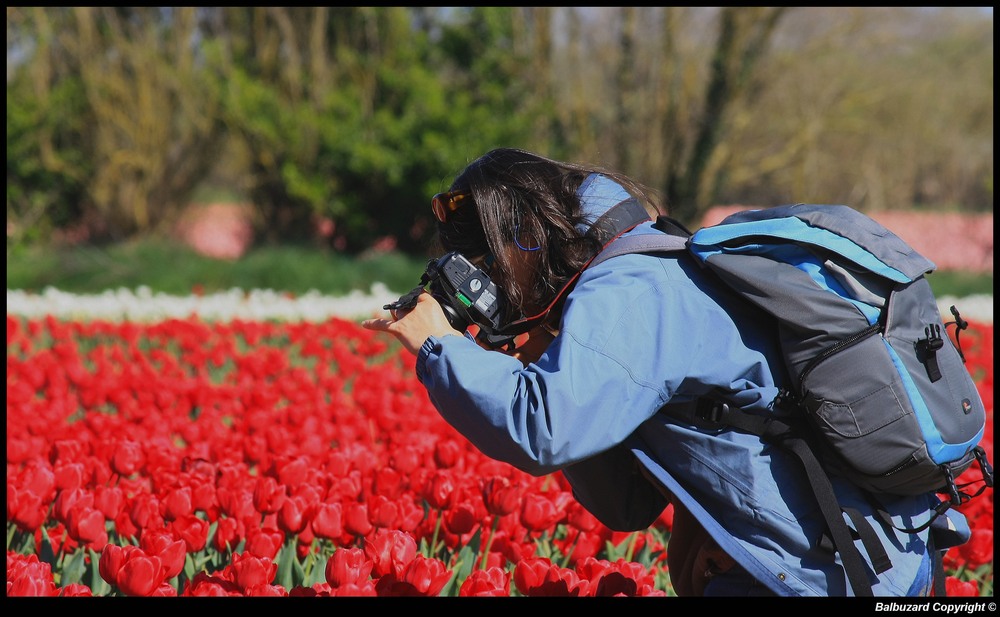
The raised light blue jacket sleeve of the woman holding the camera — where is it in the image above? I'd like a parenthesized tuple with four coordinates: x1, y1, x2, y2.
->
(416, 256, 697, 475)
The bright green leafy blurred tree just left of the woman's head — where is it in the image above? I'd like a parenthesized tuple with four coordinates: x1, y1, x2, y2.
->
(203, 7, 544, 251)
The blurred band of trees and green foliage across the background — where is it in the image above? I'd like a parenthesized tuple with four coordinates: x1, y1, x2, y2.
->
(7, 7, 993, 257)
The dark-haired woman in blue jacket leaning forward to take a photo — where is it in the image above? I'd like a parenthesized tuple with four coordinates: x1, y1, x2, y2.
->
(364, 148, 968, 596)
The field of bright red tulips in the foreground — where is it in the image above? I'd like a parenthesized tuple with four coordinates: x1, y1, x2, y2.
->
(7, 312, 994, 597)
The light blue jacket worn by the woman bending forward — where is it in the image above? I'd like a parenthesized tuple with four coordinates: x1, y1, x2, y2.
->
(416, 174, 969, 596)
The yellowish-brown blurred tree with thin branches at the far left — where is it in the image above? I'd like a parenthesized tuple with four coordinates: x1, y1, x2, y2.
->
(8, 7, 223, 241)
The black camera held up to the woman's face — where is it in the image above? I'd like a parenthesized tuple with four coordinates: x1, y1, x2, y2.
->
(382, 251, 515, 349)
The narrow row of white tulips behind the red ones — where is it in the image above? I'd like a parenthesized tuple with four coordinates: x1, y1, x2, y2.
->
(7, 283, 993, 323)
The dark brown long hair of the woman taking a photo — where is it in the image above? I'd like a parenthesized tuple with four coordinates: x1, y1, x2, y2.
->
(438, 148, 661, 319)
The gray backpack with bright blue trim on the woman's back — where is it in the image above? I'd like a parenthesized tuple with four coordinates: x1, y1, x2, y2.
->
(591, 204, 993, 595)
